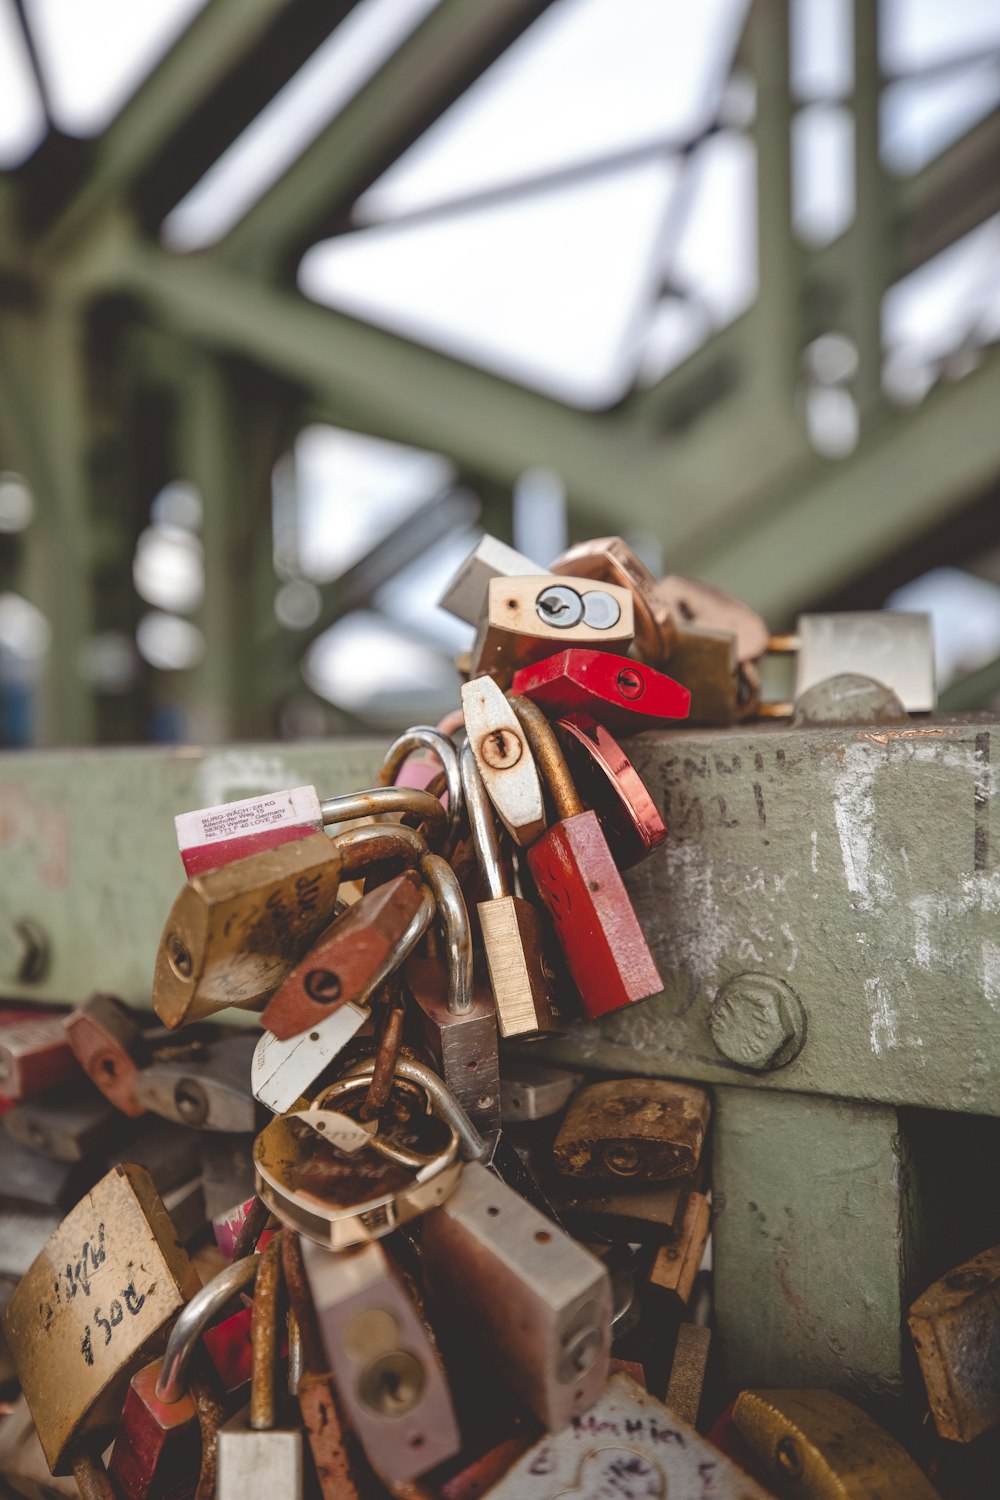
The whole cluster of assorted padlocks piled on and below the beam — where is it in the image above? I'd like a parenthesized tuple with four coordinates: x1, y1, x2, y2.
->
(0, 539, 983, 1500)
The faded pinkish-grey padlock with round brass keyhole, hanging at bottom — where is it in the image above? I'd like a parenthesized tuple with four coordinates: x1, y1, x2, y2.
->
(301, 1239, 460, 1484)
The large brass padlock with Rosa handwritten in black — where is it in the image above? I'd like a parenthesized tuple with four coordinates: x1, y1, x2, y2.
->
(3, 1166, 198, 1473)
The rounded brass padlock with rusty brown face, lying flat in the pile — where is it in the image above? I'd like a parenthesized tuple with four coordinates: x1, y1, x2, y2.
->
(253, 1058, 487, 1250)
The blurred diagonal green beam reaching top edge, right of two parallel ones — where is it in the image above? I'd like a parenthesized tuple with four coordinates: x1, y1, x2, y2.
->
(220, 0, 552, 273)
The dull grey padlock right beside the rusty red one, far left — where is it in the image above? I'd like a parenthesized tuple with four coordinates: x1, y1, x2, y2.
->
(135, 1034, 258, 1133)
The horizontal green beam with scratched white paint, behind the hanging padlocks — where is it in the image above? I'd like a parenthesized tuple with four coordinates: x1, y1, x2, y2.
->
(0, 720, 1000, 1115)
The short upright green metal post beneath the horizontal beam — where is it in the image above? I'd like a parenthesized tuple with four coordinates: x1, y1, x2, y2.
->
(712, 1089, 924, 1413)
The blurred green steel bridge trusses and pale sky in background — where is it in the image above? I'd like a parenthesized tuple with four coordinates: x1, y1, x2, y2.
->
(0, 0, 1000, 744)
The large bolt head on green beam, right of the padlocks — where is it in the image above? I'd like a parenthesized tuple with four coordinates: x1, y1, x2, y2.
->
(708, 974, 805, 1073)
